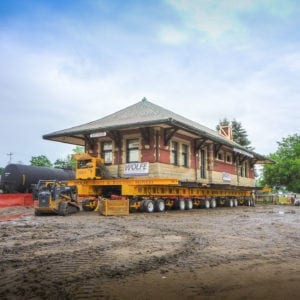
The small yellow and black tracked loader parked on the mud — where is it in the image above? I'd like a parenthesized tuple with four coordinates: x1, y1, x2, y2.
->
(33, 180, 80, 216)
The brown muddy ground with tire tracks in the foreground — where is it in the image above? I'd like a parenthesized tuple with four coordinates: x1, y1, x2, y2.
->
(0, 205, 300, 300)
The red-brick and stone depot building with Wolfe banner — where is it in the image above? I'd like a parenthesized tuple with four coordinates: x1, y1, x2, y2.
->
(43, 98, 270, 187)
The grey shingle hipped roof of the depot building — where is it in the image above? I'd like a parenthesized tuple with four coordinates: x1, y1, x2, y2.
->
(43, 98, 268, 164)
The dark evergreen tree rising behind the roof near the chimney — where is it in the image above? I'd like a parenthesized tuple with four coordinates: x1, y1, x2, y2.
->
(216, 118, 254, 150)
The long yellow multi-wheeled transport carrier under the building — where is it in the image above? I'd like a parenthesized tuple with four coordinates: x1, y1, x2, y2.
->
(68, 154, 254, 213)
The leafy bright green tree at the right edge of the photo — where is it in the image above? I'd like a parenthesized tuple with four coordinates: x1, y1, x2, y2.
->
(262, 134, 300, 193)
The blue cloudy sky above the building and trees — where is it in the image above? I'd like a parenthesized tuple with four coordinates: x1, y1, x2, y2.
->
(0, 0, 300, 167)
